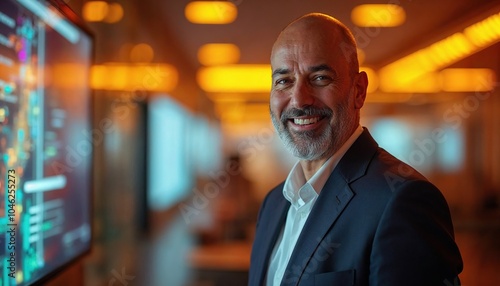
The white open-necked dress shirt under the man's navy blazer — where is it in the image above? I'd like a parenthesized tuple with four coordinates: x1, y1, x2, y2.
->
(266, 126, 363, 286)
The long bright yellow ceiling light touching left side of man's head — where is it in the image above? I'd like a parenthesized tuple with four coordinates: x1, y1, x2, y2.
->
(197, 65, 271, 93)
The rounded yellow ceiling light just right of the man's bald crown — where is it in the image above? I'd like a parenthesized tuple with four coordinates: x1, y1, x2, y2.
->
(351, 4, 406, 27)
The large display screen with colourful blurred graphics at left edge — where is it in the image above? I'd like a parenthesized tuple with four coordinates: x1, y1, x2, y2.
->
(0, 0, 93, 286)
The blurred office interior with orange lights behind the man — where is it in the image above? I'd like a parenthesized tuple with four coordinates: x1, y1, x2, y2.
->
(46, 0, 500, 286)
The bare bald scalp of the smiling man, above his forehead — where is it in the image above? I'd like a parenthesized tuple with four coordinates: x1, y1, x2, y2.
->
(271, 13, 359, 74)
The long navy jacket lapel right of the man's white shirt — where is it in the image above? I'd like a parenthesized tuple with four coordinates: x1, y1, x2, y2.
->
(281, 130, 378, 285)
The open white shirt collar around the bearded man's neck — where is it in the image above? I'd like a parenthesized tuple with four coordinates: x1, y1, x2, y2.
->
(283, 126, 363, 208)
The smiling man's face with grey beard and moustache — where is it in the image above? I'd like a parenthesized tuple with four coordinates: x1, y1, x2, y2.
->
(270, 25, 358, 160)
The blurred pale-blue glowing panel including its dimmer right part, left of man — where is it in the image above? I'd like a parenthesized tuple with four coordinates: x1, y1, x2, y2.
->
(147, 95, 222, 211)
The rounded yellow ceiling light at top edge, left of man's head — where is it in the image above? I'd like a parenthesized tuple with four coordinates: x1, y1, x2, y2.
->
(184, 1, 238, 24)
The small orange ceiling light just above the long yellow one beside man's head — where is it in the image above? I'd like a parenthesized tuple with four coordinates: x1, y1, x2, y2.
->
(198, 44, 240, 66)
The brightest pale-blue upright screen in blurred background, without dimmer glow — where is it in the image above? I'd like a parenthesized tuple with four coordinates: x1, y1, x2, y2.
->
(147, 96, 195, 211)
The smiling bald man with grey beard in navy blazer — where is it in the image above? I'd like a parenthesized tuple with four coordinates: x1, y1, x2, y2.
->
(249, 14, 462, 286)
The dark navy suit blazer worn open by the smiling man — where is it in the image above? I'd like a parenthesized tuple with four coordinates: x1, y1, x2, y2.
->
(249, 129, 463, 286)
